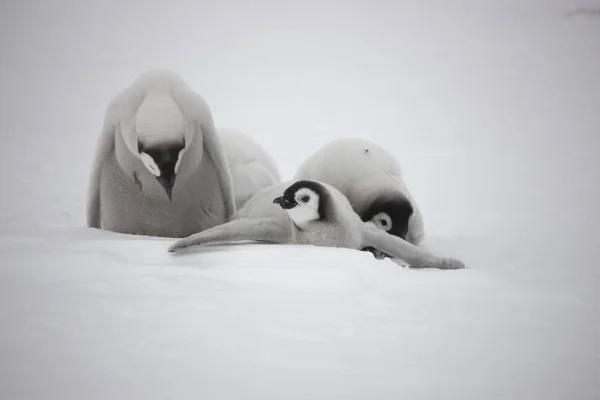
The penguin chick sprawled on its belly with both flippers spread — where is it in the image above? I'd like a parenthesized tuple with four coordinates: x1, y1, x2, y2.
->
(169, 180, 464, 269)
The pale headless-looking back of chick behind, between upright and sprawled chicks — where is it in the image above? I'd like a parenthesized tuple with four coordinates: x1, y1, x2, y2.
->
(219, 129, 281, 209)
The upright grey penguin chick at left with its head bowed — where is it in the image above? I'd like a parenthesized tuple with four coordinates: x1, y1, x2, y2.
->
(87, 70, 235, 237)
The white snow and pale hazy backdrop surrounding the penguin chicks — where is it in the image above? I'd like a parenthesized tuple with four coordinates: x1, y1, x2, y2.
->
(0, 0, 600, 399)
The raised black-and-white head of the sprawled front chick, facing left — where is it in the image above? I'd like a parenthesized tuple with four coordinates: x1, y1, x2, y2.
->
(273, 180, 328, 227)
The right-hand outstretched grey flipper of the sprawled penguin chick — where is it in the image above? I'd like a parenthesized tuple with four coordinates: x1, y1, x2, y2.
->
(361, 222, 465, 269)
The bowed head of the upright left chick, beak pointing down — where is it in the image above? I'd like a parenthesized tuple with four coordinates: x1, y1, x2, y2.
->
(134, 95, 186, 201)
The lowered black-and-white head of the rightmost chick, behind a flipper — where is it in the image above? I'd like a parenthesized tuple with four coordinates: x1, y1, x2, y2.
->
(360, 193, 414, 240)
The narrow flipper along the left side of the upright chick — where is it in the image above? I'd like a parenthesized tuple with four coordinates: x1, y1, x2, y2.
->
(87, 120, 115, 229)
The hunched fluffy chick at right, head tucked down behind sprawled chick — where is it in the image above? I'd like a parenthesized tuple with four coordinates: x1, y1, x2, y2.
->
(294, 138, 424, 245)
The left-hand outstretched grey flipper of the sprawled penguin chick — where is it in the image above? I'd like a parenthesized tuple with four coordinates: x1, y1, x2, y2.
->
(169, 218, 291, 253)
